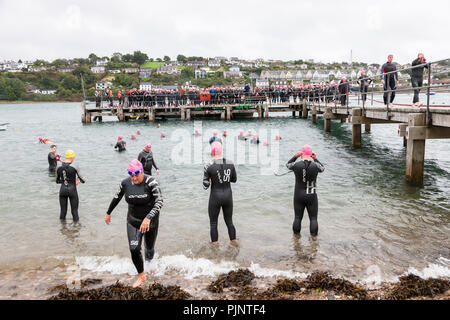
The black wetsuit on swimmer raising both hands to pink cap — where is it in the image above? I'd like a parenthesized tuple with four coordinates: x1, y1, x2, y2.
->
(286, 156, 325, 236)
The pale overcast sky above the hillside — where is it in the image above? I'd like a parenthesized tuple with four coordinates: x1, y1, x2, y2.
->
(0, 0, 450, 63)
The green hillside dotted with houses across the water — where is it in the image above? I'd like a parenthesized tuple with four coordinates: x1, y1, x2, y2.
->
(0, 51, 450, 101)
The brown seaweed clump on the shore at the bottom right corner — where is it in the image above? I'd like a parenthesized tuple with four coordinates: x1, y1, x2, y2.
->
(387, 274, 450, 300)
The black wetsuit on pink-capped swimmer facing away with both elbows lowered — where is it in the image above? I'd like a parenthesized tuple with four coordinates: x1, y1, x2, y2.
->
(203, 159, 237, 242)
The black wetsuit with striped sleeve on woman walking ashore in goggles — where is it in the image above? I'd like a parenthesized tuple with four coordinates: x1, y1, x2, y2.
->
(106, 175, 163, 273)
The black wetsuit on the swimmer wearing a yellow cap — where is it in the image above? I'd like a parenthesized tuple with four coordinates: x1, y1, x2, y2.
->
(56, 162, 85, 221)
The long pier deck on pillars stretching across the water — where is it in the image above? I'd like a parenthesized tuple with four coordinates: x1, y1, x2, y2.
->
(81, 100, 450, 184)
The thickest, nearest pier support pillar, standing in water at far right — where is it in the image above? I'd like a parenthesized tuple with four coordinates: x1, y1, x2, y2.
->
(406, 113, 425, 184)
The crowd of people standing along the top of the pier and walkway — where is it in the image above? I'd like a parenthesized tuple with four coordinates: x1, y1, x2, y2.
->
(95, 53, 427, 108)
